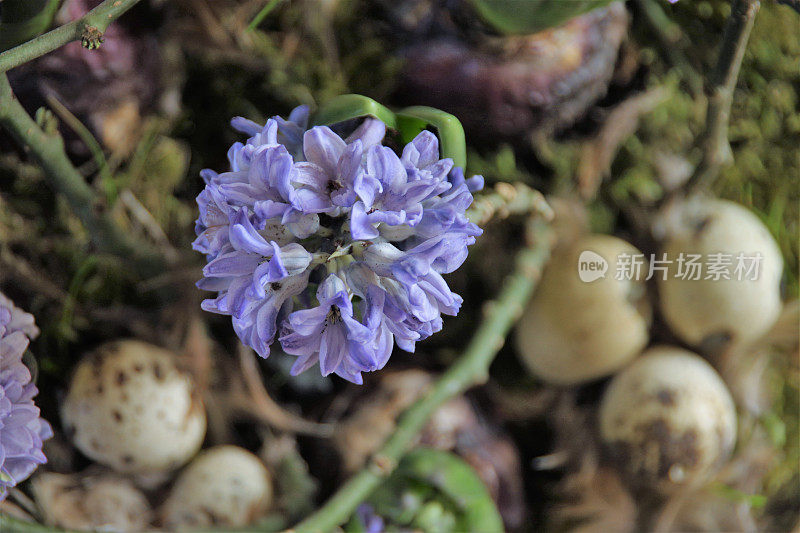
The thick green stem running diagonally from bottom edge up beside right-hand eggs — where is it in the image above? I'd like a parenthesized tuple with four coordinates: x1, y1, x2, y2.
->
(291, 218, 551, 533)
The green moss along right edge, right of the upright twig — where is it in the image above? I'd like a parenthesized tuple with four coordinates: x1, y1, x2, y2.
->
(716, 3, 800, 298)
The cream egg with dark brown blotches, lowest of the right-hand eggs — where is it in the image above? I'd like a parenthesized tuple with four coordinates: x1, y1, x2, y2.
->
(600, 346, 736, 493)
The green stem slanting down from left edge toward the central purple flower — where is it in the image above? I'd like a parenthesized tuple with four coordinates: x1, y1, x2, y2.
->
(0, 73, 165, 275)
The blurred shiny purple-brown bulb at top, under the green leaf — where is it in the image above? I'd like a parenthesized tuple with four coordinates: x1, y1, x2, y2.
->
(397, 2, 628, 138)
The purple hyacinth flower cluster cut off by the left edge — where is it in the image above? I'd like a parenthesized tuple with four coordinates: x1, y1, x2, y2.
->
(0, 293, 53, 501)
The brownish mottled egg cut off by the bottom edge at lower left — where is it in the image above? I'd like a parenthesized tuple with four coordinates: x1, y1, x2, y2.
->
(33, 472, 153, 532)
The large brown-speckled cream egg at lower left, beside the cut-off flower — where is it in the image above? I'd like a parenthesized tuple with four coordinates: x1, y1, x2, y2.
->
(61, 340, 206, 476)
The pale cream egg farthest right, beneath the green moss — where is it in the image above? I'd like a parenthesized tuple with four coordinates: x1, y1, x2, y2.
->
(657, 199, 783, 350)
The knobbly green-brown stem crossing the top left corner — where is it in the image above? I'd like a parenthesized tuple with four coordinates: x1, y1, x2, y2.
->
(0, 0, 139, 73)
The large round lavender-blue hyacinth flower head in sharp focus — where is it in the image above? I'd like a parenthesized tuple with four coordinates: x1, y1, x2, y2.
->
(193, 107, 483, 384)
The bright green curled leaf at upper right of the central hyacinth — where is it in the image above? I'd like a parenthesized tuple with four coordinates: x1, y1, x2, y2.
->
(396, 106, 467, 168)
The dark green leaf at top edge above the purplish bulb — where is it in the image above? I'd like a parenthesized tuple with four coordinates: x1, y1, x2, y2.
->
(470, 0, 613, 35)
